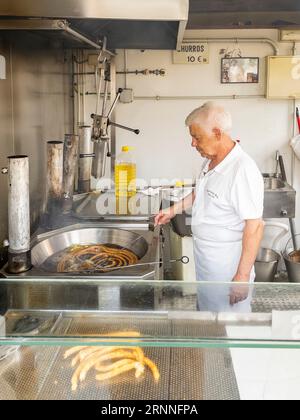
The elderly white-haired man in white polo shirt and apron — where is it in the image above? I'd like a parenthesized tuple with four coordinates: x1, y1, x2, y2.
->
(156, 103, 264, 312)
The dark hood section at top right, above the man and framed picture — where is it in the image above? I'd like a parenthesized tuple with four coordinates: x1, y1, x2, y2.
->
(187, 0, 300, 29)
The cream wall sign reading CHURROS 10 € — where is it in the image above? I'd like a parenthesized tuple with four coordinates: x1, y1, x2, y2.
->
(173, 43, 209, 64)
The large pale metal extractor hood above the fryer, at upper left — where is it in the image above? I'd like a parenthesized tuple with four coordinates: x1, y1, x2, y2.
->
(0, 0, 189, 50)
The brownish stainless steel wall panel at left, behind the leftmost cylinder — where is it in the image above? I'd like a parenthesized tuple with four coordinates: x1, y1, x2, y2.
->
(0, 34, 73, 241)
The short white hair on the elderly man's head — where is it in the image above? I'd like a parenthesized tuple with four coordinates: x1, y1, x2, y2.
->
(185, 102, 232, 134)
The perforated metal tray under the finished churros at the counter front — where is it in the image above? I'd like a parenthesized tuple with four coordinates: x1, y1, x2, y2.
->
(0, 316, 239, 400)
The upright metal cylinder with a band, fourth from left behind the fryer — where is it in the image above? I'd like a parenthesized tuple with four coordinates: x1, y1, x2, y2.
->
(78, 126, 93, 193)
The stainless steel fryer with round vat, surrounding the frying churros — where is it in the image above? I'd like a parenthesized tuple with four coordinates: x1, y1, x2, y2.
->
(2, 222, 162, 283)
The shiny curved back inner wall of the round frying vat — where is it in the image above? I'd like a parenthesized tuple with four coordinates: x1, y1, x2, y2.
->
(31, 228, 148, 268)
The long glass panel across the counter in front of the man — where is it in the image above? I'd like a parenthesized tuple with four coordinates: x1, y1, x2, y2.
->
(0, 278, 300, 349)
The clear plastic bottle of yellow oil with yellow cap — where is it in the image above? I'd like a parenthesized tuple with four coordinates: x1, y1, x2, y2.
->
(115, 146, 136, 197)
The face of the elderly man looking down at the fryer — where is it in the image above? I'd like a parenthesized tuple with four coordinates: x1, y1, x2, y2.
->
(190, 124, 220, 160)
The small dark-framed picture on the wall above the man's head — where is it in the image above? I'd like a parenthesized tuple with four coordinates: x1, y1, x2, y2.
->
(221, 57, 259, 83)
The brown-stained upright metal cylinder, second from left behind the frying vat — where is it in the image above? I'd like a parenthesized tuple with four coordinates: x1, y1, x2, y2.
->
(47, 141, 64, 215)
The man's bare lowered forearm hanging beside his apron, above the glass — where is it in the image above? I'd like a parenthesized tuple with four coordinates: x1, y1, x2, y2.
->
(235, 220, 264, 281)
